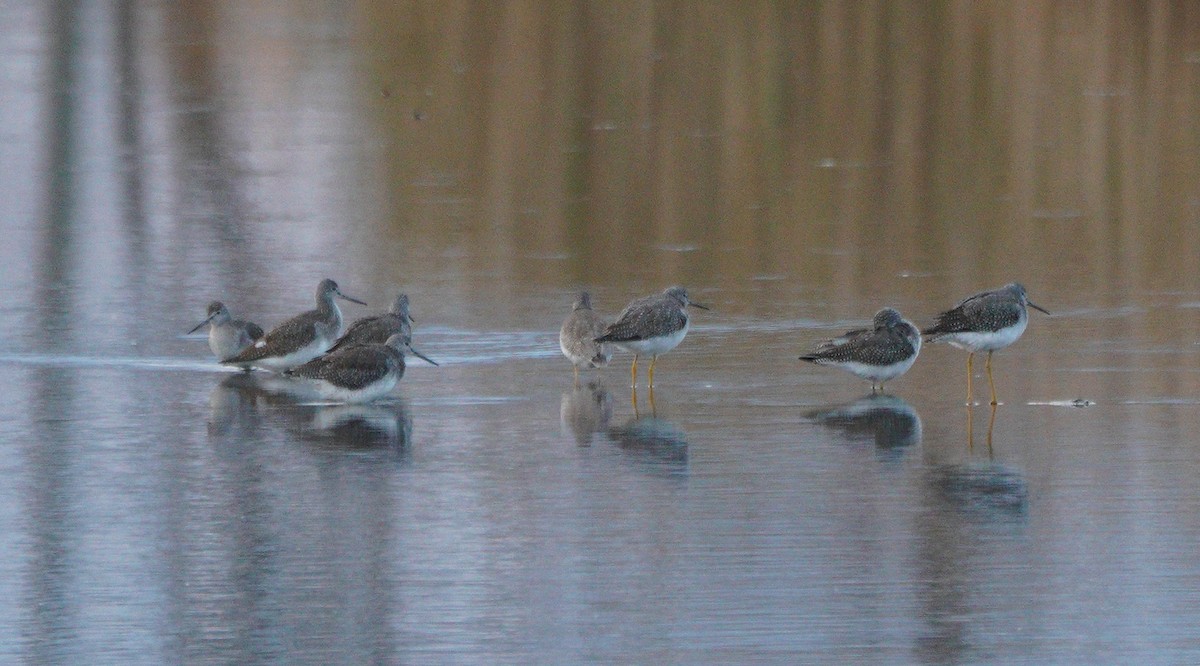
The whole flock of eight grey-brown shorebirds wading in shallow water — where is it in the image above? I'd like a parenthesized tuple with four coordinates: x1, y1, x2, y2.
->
(190, 278, 1049, 404)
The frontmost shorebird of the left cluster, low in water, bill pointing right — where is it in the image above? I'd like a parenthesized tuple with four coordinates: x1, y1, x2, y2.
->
(288, 334, 438, 402)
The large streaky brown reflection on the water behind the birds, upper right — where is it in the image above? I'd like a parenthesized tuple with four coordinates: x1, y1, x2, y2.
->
(356, 2, 1200, 299)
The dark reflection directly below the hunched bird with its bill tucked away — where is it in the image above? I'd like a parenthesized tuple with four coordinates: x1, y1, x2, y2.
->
(808, 394, 922, 450)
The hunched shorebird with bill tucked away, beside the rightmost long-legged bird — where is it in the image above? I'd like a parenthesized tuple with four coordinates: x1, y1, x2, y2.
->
(800, 307, 920, 394)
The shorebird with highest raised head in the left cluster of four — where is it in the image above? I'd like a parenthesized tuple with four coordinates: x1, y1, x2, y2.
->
(222, 278, 366, 372)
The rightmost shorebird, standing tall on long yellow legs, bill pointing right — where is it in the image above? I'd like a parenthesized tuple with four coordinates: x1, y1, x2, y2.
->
(924, 282, 1050, 404)
